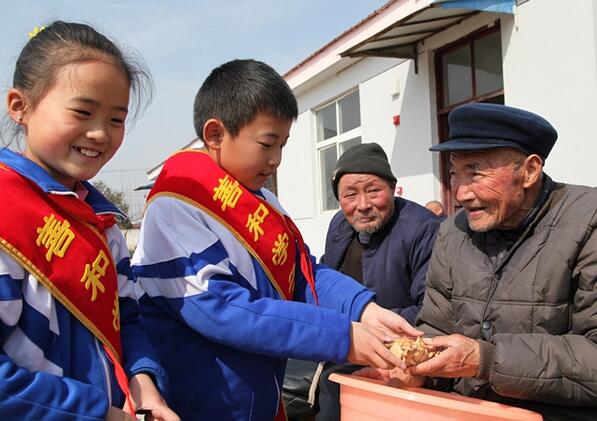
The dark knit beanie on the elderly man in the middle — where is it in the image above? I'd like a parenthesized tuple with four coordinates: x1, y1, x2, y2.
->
(332, 143, 396, 199)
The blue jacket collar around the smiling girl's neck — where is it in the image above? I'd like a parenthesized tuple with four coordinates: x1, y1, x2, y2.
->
(0, 148, 126, 219)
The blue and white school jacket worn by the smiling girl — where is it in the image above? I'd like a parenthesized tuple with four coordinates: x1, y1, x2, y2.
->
(0, 149, 166, 421)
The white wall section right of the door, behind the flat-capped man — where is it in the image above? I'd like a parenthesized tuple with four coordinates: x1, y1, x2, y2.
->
(502, 0, 597, 186)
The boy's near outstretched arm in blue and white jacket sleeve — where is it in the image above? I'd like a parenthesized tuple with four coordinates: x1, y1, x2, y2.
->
(133, 197, 354, 363)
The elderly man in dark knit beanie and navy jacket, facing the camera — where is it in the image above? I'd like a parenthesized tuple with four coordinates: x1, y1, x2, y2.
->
(316, 143, 440, 421)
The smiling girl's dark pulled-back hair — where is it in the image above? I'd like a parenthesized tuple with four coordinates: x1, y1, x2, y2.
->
(13, 21, 153, 120)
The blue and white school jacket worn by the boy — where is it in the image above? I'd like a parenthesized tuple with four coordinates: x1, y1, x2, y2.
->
(133, 189, 373, 421)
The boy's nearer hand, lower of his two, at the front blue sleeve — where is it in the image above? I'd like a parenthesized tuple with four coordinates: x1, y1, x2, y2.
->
(347, 322, 404, 368)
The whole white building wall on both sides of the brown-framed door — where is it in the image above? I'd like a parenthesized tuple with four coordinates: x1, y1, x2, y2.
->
(278, 0, 597, 257)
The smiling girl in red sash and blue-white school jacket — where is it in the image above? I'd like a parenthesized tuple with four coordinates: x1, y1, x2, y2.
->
(0, 21, 178, 420)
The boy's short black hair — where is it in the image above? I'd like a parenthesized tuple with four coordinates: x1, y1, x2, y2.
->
(193, 59, 298, 140)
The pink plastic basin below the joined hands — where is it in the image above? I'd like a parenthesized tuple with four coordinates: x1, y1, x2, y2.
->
(330, 374, 543, 421)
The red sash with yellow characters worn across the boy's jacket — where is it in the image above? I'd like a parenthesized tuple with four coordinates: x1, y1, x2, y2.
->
(147, 150, 317, 302)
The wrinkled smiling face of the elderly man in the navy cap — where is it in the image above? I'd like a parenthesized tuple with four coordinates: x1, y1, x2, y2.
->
(450, 148, 530, 232)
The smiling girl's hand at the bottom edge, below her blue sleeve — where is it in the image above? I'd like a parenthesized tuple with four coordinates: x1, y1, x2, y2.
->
(125, 373, 180, 421)
